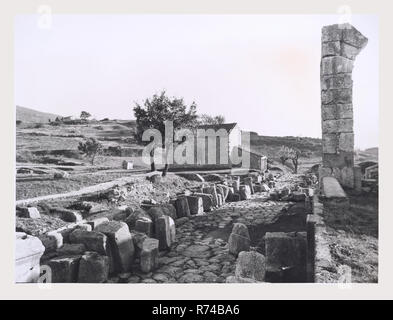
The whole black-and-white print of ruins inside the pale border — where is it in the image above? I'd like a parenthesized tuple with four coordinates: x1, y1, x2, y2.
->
(14, 12, 379, 286)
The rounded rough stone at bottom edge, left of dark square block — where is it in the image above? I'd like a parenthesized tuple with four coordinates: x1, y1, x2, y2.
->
(235, 251, 266, 281)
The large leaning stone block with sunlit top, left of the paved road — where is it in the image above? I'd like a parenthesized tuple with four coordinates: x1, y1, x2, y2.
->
(96, 221, 134, 272)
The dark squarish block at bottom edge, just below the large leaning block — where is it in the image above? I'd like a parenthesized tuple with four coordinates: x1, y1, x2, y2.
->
(78, 252, 109, 283)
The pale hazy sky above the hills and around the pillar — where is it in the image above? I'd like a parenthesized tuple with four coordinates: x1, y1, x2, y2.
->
(15, 15, 379, 148)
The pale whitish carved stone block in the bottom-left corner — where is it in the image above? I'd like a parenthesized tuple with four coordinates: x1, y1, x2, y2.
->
(15, 232, 45, 283)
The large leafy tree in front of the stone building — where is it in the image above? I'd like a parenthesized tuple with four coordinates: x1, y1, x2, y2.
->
(134, 91, 197, 176)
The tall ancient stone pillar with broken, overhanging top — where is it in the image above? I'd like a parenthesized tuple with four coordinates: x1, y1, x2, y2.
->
(320, 23, 368, 188)
